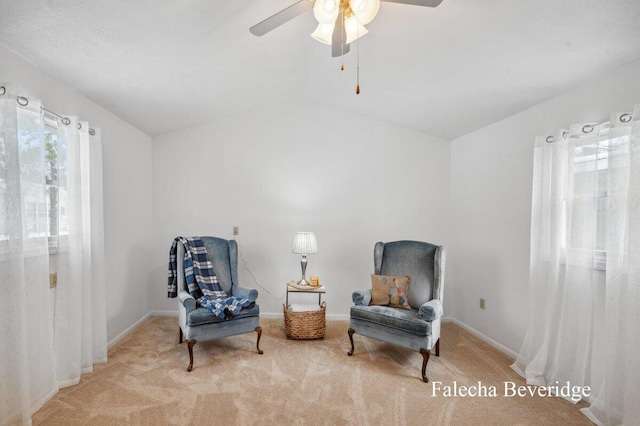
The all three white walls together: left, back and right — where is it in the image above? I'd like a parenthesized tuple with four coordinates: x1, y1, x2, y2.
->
(8, 38, 640, 366)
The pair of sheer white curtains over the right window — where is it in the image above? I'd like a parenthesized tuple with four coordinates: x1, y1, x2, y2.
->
(512, 104, 640, 424)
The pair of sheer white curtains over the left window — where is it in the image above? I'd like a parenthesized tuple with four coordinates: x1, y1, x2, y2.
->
(0, 84, 107, 424)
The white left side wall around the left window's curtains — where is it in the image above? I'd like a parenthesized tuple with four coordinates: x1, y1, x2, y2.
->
(0, 47, 151, 341)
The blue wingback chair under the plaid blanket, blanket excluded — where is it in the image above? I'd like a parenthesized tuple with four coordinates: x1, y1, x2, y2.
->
(176, 237, 262, 371)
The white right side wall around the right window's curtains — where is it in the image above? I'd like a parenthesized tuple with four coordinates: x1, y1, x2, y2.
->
(450, 57, 640, 352)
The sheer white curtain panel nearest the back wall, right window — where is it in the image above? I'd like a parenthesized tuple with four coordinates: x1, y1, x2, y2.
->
(514, 125, 602, 386)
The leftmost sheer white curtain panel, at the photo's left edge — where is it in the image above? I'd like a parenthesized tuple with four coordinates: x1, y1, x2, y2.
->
(0, 85, 58, 424)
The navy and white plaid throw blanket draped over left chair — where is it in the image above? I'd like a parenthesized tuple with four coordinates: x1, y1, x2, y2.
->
(167, 237, 253, 319)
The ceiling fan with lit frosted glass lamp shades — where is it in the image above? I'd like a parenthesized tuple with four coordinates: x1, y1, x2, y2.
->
(249, 0, 442, 58)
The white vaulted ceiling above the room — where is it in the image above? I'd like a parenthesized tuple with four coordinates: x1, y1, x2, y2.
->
(0, 0, 640, 139)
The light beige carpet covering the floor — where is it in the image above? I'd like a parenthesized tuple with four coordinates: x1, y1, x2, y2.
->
(33, 317, 591, 426)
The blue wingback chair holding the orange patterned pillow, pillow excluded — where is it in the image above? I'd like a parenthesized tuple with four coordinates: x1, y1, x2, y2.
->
(348, 241, 445, 382)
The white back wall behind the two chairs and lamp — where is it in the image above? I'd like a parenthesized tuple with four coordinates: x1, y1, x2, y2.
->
(151, 101, 451, 318)
